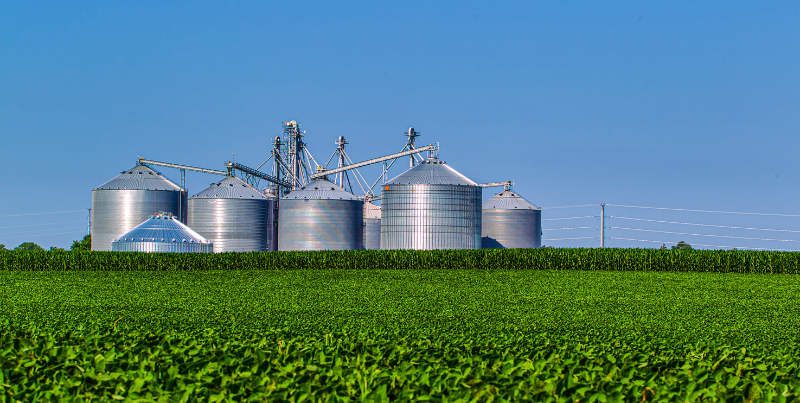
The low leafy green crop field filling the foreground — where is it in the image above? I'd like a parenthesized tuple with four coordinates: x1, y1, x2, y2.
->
(0, 254, 800, 403)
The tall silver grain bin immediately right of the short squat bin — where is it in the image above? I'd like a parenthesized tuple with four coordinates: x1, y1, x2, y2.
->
(189, 176, 275, 253)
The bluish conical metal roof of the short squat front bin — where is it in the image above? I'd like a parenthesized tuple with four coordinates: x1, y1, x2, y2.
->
(114, 213, 211, 244)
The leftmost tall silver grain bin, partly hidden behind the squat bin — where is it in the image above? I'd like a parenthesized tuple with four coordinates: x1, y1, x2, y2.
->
(91, 165, 187, 251)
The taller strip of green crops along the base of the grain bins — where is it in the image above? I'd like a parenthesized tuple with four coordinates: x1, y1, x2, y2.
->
(0, 248, 800, 273)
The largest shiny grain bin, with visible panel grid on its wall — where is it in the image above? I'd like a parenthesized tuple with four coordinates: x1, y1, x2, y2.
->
(381, 157, 481, 250)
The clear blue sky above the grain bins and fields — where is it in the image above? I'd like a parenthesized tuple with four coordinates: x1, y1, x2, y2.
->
(0, 1, 800, 249)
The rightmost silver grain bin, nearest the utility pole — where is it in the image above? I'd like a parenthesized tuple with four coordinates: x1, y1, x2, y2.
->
(481, 189, 542, 249)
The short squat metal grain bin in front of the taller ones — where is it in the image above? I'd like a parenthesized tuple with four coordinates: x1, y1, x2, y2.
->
(111, 212, 214, 253)
